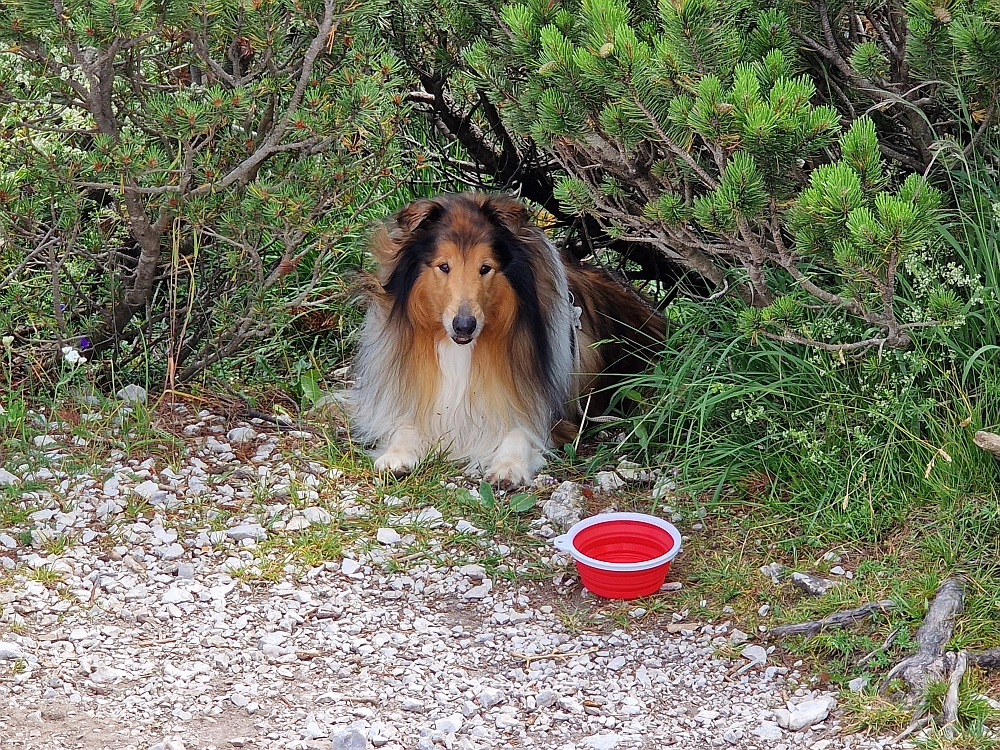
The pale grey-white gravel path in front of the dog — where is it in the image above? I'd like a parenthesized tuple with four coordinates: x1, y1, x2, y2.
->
(0, 412, 881, 750)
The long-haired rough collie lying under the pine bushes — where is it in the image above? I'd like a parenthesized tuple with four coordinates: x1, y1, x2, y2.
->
(349, 194, 664, 486)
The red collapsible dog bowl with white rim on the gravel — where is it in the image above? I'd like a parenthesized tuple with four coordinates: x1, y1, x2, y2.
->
(552, 513, 681, 599)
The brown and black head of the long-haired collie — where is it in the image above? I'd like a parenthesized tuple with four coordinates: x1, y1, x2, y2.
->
(374, 194, 534, 345)
